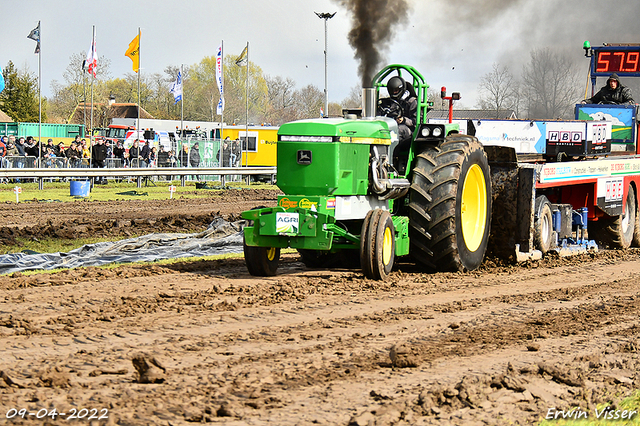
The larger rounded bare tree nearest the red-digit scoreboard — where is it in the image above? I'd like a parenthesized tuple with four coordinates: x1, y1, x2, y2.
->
(522, 48, 581, 119)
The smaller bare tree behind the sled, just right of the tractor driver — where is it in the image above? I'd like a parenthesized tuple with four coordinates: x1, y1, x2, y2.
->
(477, 63, 519, 118)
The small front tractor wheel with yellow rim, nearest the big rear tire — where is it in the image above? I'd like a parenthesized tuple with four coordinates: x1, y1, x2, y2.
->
(360, 209, 396, 280)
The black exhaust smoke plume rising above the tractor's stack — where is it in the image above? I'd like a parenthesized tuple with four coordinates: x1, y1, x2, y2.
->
(334, 0, 409, 87)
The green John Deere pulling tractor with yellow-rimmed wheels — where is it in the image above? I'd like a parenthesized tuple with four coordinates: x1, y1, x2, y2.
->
(242, 65, 491, 280)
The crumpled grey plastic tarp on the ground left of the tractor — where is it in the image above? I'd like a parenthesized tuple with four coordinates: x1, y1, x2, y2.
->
(0, 218, 244, 274)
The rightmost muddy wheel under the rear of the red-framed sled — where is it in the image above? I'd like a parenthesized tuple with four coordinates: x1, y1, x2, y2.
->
(589, 185, 637, 249)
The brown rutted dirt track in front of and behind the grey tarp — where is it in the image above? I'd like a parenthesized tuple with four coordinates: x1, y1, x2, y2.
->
(0, 191, 640, 425)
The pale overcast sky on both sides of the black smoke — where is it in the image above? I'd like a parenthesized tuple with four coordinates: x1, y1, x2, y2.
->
(0, 0, 640, 107)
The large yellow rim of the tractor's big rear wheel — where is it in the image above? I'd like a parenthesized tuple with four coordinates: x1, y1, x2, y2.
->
(460, 164, 487, 252)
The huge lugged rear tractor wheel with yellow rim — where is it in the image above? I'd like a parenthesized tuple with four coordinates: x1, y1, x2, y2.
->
(409, 134, 491, 271)
